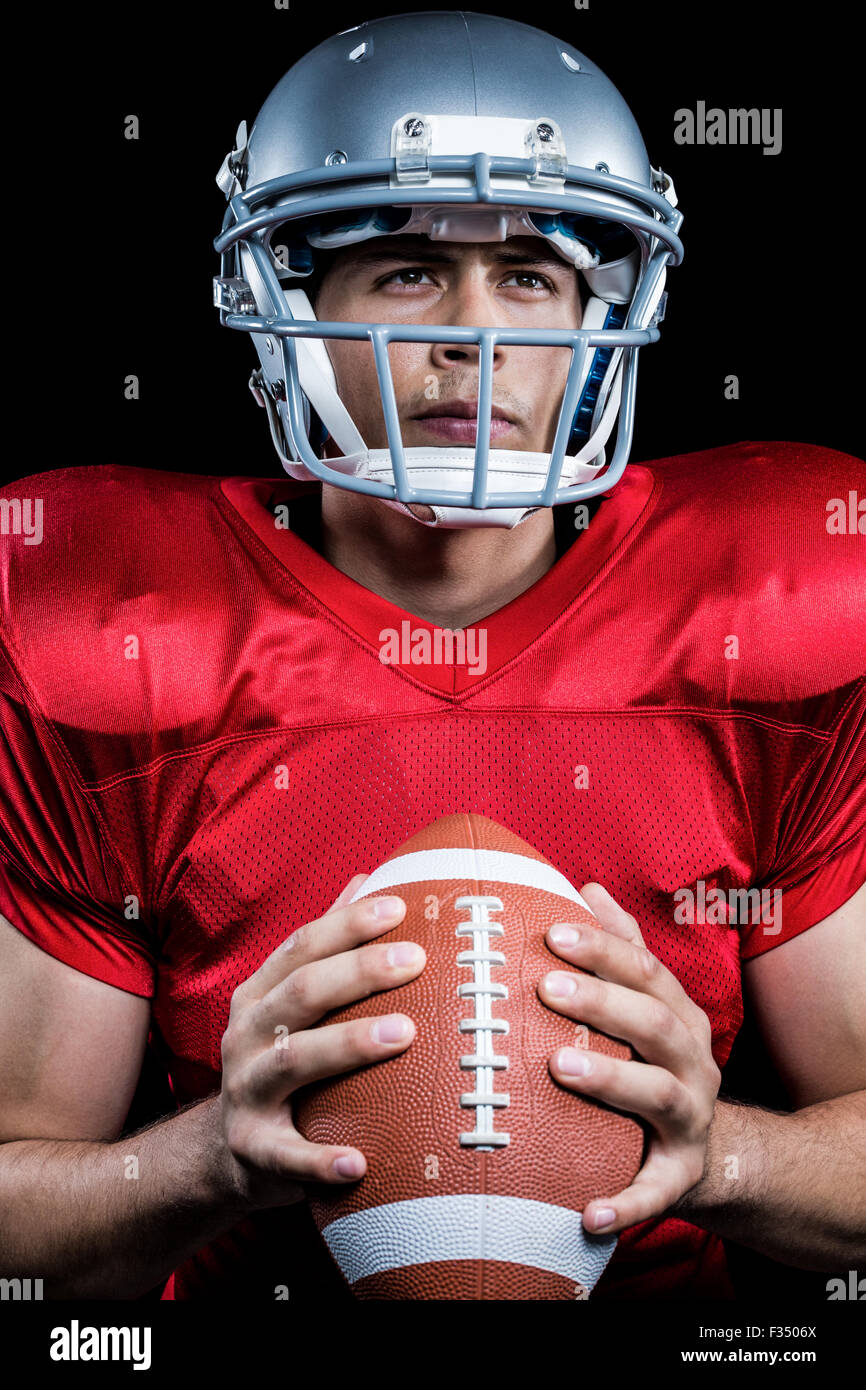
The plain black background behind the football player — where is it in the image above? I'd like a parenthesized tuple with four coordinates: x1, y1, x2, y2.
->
(4, 0, 863, 1302)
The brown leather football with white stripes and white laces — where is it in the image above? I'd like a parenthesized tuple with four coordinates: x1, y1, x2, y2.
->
(293, 813, 644, 1300)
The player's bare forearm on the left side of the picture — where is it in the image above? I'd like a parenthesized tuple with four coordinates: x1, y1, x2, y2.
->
(0, 1097, 250, 1298)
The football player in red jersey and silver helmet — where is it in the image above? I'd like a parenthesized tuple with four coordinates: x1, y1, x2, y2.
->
(0, 11, 866, 1300)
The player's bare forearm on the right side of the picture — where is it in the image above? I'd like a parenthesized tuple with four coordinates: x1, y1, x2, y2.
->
(671, 1091, 866, 1272)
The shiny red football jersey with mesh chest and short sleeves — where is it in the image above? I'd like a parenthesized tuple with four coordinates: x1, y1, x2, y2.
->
(0, 443, 866, 1298)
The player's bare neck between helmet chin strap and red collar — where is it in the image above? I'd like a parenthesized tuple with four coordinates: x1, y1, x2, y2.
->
(289, 484, 583, 630)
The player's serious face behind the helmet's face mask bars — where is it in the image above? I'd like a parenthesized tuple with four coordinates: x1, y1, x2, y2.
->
(316, 236, 581, 456)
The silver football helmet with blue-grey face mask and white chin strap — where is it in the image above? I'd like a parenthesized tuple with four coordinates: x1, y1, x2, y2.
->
(214, 11, 683, 527)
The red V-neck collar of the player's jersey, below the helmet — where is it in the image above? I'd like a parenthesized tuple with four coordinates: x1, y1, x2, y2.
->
(220, 464, 660, 698)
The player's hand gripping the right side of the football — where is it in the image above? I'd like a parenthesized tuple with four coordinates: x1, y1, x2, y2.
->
(538, 883, 721, 1234)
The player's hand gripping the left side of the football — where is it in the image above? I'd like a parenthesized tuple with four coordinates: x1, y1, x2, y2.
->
(220, 874, 427, 1208)
